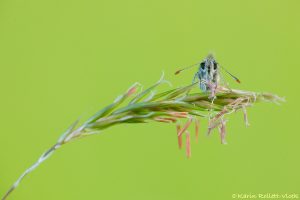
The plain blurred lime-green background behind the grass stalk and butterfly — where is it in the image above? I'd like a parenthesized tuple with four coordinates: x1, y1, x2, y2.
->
(0, 0, 300, 200)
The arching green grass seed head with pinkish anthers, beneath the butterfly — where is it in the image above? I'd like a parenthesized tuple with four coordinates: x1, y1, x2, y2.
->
(2, 74, 284, 200)
